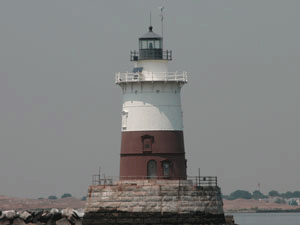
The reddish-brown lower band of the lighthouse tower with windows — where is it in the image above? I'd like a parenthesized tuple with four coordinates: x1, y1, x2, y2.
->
(120, 131, 186, 179)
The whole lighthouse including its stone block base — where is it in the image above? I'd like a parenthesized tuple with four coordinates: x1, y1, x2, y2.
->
(83, 22, 225, 225)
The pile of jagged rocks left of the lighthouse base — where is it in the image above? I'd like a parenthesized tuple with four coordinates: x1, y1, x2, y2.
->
(0, 208, 84, 225)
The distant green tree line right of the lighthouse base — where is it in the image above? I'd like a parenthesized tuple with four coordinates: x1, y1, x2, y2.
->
(223, 190, 300, 200)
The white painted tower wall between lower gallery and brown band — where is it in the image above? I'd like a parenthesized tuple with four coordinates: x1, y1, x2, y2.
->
(122, 82, 183, 131)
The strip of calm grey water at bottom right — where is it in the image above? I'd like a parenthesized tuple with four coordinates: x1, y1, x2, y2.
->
(232, 213, 300, 225)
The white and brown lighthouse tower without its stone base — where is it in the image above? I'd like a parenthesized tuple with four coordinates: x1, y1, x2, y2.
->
(115, 26, 187, 180)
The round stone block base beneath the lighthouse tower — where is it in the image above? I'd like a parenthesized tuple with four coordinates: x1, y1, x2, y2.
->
(83, 180, 225, 225)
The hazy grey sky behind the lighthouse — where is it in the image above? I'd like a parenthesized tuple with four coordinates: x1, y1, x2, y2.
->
(0, 0, 300, 198)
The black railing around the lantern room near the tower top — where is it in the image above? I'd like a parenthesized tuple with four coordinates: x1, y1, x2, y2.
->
(130, 49, 172, 61)
